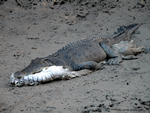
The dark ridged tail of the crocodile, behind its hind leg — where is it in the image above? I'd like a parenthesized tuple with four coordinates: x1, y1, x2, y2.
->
(109, 23, 142, 45)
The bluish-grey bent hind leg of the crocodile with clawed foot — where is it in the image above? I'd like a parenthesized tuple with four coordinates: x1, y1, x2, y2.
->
(99, 42, 122, 65)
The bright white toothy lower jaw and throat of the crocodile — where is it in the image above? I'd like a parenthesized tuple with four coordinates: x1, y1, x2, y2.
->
(10, 66, 77, 87)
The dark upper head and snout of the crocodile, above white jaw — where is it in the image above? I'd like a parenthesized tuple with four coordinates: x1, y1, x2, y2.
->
(10, 58, 53, 86)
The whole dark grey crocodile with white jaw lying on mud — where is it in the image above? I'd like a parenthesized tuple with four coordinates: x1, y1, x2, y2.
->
(10, 23, 144, 86)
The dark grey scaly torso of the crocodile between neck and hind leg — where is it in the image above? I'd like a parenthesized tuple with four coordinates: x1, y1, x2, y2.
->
(52, 38, 106, 65)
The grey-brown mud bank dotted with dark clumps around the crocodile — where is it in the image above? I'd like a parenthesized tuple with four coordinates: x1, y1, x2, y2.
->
(0, 0, 150, 113)
